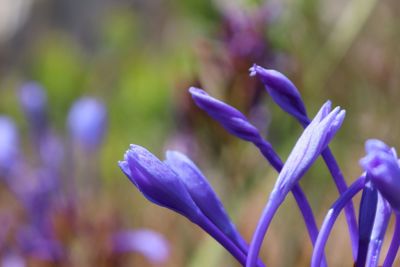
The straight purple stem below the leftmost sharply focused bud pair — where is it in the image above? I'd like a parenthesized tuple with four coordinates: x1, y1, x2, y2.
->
(195, 216, 265, 267)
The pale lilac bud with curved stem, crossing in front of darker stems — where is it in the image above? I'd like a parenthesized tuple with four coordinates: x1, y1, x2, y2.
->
(246, 101, 345, 267)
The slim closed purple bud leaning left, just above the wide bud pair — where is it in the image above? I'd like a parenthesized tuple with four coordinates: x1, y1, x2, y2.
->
(189, 87, 261, 142)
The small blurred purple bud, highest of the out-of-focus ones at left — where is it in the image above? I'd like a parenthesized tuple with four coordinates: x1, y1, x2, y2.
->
(19, 82, 47, 135)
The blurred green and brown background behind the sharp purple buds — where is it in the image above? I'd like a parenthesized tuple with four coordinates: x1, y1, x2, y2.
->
(0, 0, 400, 267)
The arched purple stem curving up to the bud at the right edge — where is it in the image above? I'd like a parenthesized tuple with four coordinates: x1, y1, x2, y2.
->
(311, 175, 365, 267)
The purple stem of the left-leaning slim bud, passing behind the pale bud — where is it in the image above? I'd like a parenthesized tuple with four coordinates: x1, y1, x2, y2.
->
(255, 140, 327, 267)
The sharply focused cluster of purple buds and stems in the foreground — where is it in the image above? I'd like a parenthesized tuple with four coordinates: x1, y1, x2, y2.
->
(119, 65, 400, 267)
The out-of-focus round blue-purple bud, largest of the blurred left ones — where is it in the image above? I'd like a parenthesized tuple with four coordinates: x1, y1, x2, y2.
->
(68, 97, 107, 150)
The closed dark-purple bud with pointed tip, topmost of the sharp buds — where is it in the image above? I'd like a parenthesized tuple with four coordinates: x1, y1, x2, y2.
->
(250, 64, 309, 124)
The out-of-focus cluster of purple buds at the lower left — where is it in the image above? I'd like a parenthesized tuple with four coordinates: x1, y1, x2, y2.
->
(0, 85, 169, 267)
